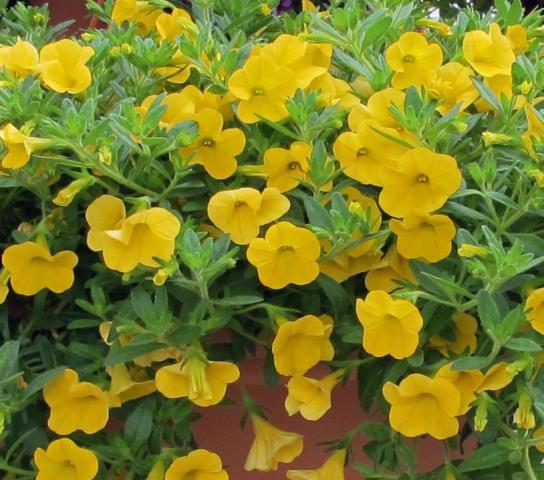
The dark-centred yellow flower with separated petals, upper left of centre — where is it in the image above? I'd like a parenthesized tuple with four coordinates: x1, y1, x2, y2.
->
(181, 108, 246, 180)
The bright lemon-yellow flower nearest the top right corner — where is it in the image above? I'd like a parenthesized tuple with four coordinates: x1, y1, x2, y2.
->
(463, 23, 516, 77)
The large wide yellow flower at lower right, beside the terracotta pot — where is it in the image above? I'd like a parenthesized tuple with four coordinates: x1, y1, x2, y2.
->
(383, 373, 461, 440)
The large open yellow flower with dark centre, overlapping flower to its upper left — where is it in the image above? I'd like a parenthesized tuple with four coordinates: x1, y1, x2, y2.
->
(379, 147, 462, 217)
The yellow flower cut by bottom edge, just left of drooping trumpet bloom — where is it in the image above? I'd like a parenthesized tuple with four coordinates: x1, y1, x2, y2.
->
(164, 449, 229, 480)
